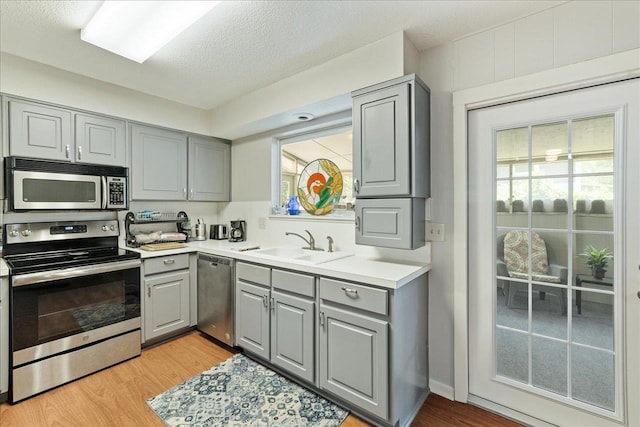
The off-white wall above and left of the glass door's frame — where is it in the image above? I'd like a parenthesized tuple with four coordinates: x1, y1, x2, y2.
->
(419, 1, 640, 397)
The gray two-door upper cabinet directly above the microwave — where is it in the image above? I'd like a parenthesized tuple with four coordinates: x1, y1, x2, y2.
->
(8, 100, 127, 166)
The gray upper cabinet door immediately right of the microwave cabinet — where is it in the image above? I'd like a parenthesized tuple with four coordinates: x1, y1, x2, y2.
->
(131, 124, 187, 200)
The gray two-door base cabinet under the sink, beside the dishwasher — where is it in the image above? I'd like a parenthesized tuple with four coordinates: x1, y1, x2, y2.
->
(236, 262, 316, 383)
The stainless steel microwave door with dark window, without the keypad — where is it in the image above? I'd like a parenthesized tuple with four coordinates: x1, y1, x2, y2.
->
(11, 170, 103, 210)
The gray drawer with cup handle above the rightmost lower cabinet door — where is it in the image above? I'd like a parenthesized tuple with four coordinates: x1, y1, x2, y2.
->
(320, 277, 388, 315)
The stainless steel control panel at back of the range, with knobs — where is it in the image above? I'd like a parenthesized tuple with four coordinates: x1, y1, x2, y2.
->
(5, 220, 120, 245)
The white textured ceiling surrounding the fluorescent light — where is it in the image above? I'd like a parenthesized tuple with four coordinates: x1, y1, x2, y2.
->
(0, 0, 562, 109)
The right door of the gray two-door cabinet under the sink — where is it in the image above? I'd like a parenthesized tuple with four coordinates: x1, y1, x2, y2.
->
(271, 291, 315, 383)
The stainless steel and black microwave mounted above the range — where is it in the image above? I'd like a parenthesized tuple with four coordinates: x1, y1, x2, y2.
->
(4, 157, 129, 211)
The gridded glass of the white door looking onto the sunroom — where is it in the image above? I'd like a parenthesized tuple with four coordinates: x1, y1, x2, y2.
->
(494, 115, 617, 410)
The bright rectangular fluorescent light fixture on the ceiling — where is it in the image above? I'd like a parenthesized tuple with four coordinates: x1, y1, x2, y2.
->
(80, 0, 220, 63)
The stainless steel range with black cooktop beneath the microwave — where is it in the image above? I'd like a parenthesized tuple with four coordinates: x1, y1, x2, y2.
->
(4, 220, 141, 402)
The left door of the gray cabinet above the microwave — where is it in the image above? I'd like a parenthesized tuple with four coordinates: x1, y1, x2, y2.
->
(9, 101, 73, 161)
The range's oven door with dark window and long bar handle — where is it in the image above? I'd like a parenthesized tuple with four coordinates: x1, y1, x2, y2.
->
(11, 260, 140, 368)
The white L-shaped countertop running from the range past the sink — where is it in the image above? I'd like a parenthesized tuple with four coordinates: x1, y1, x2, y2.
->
(127, 240, 431, 289)
